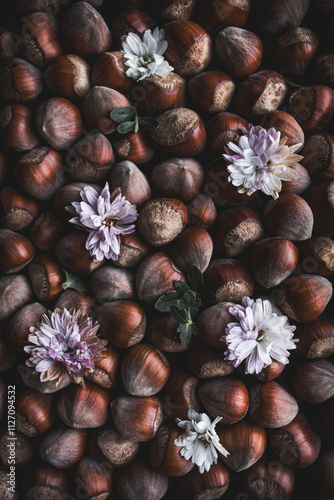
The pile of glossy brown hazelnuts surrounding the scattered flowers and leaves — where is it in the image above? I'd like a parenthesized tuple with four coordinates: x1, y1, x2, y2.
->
(0, 0, 334, 500)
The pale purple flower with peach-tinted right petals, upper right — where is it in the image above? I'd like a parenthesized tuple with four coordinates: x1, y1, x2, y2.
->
(223, 126, 303, 199)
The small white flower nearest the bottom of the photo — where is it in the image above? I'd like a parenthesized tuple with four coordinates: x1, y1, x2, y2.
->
(174, 410, 229, 474)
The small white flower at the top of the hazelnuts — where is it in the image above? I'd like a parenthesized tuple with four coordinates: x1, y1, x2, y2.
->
(122, 28, 174, 81)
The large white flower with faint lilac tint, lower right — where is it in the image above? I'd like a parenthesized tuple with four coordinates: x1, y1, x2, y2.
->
(220, 297, 298, 373)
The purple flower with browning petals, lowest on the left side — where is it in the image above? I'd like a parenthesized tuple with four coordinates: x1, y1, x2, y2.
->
(24, 309, 107, 387)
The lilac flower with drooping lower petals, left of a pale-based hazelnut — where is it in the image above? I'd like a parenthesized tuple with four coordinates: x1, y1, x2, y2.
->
(66, 182, 138, 262)
